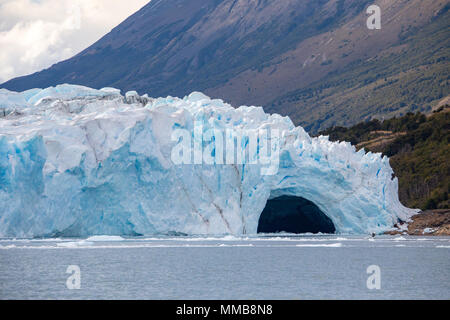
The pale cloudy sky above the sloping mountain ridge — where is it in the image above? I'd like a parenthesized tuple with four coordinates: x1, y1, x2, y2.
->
(0, 0, 149, 83)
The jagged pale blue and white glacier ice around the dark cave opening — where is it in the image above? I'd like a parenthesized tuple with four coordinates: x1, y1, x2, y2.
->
(0, 85, 416, 237)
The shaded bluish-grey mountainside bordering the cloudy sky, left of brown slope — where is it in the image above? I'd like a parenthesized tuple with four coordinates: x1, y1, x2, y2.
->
(2, 0, 360, 95)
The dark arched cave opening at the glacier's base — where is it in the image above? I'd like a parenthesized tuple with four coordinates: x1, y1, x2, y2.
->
(258, 196, 336, 233)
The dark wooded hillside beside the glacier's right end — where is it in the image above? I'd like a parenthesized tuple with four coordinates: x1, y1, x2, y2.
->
(320, 105, 450, 210)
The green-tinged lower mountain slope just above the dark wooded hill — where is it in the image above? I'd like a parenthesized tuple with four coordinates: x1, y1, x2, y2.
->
(269, 7, 450, 131)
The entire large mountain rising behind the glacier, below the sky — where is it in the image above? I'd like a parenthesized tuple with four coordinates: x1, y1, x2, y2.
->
(0, 0, 450, 132)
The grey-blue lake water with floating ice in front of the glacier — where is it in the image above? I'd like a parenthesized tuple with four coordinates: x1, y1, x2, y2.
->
(0, 235, 450, 300)
